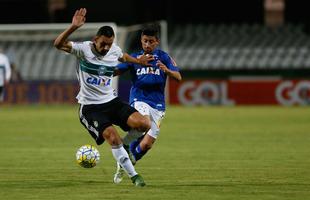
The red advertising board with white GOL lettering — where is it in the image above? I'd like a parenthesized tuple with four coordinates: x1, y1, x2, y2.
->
(169, 77, 310, 106)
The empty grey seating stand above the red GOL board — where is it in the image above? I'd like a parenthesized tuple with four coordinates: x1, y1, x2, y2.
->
(169, 24, 310, 70)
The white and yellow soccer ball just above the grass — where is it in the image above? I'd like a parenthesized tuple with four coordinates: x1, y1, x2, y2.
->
(76, 144, 100, 168)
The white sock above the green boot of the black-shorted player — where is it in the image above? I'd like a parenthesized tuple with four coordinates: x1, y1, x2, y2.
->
(112, 146, 138, 177)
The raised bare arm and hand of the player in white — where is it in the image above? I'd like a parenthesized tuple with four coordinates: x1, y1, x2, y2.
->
(54, 8, 86, 53)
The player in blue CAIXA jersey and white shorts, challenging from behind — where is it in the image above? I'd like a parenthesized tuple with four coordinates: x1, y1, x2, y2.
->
(114, 24, 182, 183)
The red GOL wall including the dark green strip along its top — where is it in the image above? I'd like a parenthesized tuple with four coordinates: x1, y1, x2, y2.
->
(169, 69, 310, 106)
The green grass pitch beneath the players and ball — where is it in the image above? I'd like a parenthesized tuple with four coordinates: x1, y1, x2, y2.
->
(0, 106, 310, 200)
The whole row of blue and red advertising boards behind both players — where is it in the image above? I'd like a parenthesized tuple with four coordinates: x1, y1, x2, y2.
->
(4, 76, 310, 106)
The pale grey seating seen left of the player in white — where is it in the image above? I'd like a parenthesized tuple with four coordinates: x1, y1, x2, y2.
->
(0, 41, 75, 80)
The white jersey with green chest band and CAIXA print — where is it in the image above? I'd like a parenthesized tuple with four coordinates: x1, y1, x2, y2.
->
(71, 41, 123, 105)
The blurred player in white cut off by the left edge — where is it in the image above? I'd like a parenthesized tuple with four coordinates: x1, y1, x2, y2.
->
(0, 50, 11, 102)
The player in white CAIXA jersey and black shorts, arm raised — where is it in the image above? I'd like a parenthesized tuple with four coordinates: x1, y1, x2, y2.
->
(54, 8, 153, 187)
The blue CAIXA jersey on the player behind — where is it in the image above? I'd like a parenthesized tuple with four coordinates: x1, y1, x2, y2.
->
(117, 49, 179, 111)
